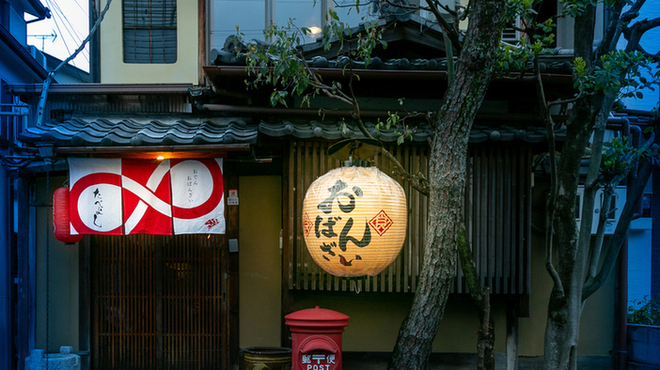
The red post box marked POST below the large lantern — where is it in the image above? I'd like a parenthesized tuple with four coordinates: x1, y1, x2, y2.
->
(284, 306, 348, 370)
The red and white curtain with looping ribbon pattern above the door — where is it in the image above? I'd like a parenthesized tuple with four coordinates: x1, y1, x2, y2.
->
(69, 158, 225, 235)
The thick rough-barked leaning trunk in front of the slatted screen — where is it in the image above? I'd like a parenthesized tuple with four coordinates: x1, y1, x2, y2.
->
(388, 0, 505, 370)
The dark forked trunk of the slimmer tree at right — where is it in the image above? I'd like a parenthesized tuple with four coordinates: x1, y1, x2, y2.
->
(544, 6, 614, 370)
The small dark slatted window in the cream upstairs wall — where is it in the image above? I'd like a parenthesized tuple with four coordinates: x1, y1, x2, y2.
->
(122, 0, 177, 64)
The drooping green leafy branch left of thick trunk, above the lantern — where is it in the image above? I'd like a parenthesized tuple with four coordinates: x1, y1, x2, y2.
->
(240, 11, 429, 195)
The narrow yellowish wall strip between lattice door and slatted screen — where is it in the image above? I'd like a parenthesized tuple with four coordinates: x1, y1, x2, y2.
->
(238, 176, 282, 348)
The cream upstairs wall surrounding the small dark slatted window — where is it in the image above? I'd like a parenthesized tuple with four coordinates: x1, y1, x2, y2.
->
(101, 0, 199, 84)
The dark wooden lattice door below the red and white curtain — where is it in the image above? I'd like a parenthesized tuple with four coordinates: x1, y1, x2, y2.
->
(91, 235, 225, 370)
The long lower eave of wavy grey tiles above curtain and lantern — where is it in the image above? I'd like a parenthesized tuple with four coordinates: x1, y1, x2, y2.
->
(21, 118, 565, 147)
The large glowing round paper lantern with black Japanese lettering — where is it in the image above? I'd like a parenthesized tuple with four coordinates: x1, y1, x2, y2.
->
(302, 166, 407, 277)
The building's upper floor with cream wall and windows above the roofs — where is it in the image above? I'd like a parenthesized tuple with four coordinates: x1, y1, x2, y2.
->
(90, 0, 604, 85)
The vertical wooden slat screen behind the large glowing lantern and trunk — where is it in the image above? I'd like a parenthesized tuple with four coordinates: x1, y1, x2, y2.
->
(284, 141, 532, 294)
